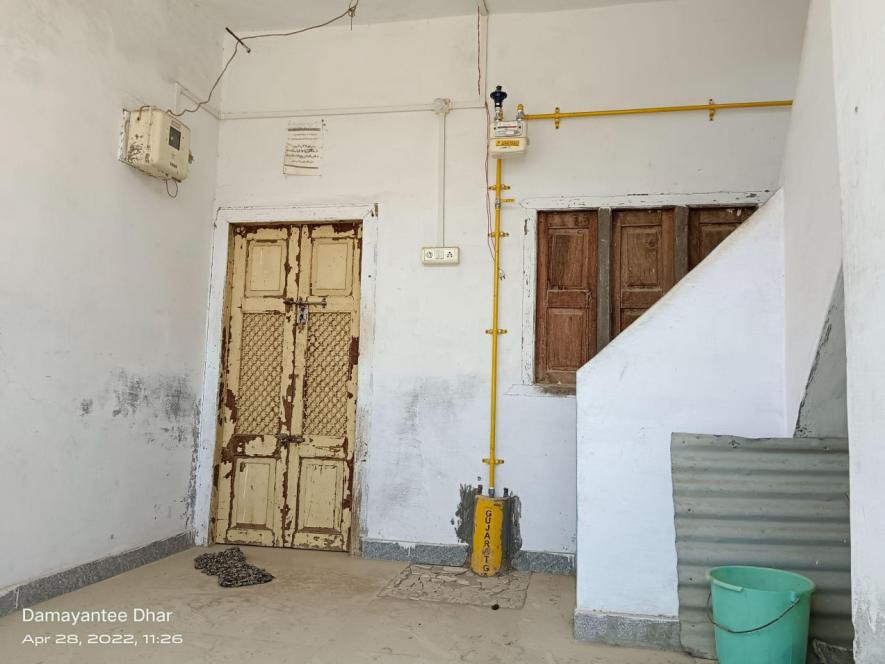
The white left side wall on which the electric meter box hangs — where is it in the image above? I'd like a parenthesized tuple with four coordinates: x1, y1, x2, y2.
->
(0, 0, 220, 588)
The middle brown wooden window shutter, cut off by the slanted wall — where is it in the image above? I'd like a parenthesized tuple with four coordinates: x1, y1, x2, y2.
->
(611, 209, 675, 336)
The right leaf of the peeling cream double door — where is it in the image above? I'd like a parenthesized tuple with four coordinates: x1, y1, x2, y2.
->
(286, 224, 361, 549)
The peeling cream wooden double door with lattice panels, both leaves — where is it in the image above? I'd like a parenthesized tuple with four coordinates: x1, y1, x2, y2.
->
(214, 223, 361, 550)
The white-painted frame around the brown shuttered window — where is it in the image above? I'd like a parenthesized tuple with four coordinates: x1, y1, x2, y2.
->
(505, 190, 774, 399)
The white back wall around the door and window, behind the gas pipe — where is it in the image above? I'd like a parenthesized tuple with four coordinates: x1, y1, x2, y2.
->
(211, 0, 805, 556)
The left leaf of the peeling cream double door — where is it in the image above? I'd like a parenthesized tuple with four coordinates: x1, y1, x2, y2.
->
(215, 227, 300, 546)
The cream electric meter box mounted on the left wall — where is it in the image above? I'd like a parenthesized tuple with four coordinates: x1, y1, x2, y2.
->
(120, 106, 191, 182)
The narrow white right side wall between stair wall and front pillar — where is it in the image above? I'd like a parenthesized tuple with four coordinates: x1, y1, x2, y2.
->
(782, 0, 842, 424)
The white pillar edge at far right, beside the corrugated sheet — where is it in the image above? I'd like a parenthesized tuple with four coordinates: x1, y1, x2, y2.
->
(832, 0, 885, 664)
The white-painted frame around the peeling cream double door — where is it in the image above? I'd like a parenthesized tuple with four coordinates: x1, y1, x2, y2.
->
(189, 203, 379, 554)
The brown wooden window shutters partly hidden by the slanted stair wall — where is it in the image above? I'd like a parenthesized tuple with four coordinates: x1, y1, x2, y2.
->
(535, 206, 756, 386)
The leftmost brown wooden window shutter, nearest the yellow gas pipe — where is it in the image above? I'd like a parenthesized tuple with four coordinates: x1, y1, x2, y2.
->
(535, 210, 598, 385)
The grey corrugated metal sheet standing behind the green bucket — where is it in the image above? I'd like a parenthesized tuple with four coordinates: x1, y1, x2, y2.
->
(671, 434, 854, 658)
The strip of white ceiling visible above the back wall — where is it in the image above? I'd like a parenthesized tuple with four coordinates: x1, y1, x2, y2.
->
(197, 0, 668, 31)
